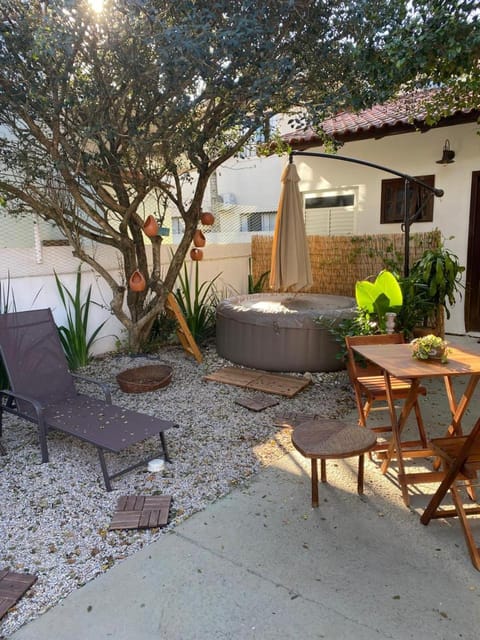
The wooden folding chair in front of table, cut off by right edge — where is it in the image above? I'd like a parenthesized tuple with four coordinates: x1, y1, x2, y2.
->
(420, 418, 480, 571)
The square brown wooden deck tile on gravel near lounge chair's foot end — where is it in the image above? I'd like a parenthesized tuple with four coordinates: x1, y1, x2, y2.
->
(109, 496, 172, 530)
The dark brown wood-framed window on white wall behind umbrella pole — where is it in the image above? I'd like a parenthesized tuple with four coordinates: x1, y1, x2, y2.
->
(380, 175, 435, 224)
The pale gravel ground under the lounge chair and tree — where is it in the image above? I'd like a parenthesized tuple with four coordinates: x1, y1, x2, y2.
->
(0, 346, 354, 640)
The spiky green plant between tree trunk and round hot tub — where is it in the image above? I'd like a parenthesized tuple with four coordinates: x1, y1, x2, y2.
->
(174, 262, 220, 342)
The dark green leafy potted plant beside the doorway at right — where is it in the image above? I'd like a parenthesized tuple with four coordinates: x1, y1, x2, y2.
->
(410, 245, 465, 320)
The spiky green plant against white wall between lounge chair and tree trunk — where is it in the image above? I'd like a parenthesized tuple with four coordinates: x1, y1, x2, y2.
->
(55, 266, 106, 371)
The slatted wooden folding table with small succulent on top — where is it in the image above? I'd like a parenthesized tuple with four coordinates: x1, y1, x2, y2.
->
(354, 344, 480, 505)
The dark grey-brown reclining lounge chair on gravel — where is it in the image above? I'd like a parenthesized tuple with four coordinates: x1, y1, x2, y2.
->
(0, 309, 176, 491)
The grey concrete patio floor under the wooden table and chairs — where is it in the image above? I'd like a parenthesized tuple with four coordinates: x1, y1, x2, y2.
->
(7, 336, 480, 640)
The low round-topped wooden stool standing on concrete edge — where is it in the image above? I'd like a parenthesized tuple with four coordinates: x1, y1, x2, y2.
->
(292, 418, 377, 507)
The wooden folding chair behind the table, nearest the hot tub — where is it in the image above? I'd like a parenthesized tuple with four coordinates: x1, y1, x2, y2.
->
(345, 333, 427, 451)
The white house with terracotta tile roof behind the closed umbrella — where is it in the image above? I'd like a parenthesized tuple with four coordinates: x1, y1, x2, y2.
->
(218, 97, 480, 335)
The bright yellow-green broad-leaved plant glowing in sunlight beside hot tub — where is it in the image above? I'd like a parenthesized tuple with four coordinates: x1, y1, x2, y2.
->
(355, 271, 403, 332)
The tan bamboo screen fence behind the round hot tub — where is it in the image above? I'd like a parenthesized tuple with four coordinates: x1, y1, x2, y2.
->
(252, 229, 442, 296)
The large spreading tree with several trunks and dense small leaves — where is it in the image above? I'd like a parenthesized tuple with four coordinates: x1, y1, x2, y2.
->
(0, 0, 478, 349)
